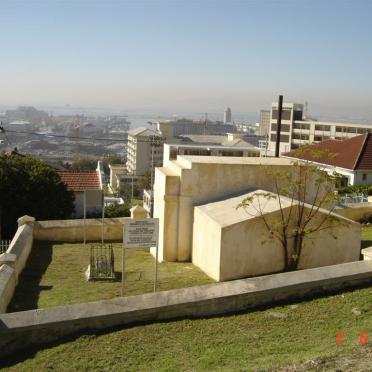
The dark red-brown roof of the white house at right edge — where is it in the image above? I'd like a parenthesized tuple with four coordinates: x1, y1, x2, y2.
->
(285, 133, 372, 170)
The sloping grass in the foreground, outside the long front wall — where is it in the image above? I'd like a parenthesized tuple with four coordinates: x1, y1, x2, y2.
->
(2, 227, 372, 371)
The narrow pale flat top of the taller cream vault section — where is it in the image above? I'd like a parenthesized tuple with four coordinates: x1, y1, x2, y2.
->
(177, 155, 293, 165)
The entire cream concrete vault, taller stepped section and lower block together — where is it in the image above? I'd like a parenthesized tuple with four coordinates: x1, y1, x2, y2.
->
(154, 156, 360, 280)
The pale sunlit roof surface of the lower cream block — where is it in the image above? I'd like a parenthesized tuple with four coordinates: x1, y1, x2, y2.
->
(195, 189, 291, 227)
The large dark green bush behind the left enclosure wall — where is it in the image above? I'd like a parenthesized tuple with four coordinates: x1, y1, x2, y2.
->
(0, 154, 74, 238)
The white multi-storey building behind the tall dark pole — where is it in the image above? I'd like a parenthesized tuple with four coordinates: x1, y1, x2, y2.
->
(268, 103, 372, 155)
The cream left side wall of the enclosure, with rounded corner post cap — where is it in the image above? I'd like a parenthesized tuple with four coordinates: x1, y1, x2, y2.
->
(0, 216, 33, 313)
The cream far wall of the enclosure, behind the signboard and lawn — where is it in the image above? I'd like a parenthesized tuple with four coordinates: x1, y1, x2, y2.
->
(34, 217, 131, 242)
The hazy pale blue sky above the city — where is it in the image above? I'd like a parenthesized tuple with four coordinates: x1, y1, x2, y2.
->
(0, 0, 372, 123)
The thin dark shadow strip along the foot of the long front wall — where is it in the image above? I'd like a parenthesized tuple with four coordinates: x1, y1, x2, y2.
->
(0, 281, 372, 367)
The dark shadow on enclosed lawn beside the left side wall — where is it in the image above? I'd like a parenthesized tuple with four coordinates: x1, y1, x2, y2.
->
(7, 242, 53, 313)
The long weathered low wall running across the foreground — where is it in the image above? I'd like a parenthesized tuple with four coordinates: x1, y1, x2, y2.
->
(0, 261, 372, 356)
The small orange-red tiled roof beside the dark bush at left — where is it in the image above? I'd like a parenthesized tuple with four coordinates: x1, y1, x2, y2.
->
(57, 170, 100, 191)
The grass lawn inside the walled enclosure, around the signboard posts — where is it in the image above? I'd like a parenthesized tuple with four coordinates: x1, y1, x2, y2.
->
(8, 241, 214, 312)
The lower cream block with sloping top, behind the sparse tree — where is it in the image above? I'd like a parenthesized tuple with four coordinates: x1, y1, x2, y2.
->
(192, 190, 360, 281)
